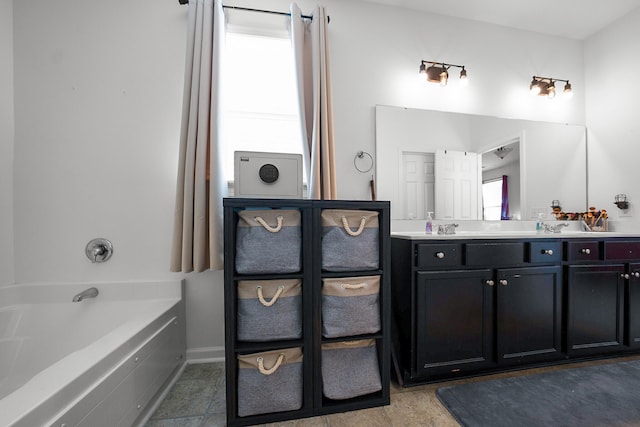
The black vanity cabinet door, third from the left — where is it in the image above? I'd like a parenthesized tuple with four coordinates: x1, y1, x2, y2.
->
(567, 265, 625, 356)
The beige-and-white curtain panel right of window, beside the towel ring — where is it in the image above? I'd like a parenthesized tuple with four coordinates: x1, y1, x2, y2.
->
(290, 3, 337, 200)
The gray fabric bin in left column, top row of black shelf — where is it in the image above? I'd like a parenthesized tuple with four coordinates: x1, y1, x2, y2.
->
(236, 209, 302, 274)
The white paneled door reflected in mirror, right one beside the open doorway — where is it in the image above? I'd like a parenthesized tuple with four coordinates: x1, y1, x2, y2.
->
(435, 150, 482, 220)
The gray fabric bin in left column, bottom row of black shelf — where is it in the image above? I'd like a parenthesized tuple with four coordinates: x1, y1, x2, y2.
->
(237, 347, 303, 417)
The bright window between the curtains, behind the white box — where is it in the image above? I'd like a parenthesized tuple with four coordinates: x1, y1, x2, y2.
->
(220, 32, 304, 181)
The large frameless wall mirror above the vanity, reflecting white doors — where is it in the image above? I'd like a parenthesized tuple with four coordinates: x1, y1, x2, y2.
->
(375, 105, 587, 220)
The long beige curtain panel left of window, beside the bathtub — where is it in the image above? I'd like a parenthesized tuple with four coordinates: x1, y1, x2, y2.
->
(171, 0, 225, 272)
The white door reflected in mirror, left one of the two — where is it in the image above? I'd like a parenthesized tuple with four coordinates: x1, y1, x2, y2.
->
(400, 151, 435, 219)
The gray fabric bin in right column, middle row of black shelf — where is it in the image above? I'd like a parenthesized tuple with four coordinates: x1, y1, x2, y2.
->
(322, 276, 380, 338)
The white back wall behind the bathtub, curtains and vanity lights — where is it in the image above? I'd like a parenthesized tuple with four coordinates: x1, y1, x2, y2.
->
(11, 0, 585, 357)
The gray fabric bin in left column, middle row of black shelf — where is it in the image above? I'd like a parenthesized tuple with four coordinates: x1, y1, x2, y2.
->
(237, 279, 302, 341)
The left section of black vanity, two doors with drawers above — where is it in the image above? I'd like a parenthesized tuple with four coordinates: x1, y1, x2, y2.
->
(392, 238, 563, 385)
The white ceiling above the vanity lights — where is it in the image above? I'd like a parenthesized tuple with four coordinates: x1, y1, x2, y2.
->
(363, 0, 640, 40)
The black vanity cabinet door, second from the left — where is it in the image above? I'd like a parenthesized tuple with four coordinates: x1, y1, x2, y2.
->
(496, 267, 562, 363)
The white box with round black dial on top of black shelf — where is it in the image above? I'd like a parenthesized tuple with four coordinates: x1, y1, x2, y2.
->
(233, 151, 302, 199)
